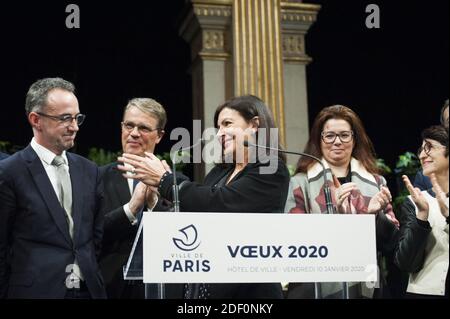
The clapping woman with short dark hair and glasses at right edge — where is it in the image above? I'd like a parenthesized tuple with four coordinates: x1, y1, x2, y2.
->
(395, 126, 449, 299)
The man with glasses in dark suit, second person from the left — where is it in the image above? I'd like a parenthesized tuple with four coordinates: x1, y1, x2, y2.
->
(100, 98, 177, 299)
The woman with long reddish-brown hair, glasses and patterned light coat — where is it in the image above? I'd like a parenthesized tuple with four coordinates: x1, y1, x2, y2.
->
(285, 105, 399, 298)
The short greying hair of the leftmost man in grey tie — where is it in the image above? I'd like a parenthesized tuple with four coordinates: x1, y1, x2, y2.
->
(25, 78, 75, 115)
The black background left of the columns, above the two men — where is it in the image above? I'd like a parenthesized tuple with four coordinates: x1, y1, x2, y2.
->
(0, 0, 192, 155)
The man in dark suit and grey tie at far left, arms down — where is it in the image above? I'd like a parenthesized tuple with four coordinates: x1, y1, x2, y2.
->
(0, 78, 106, 299)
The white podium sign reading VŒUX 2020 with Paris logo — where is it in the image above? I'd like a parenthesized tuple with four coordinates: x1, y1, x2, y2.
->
(143, 212, 378, 283)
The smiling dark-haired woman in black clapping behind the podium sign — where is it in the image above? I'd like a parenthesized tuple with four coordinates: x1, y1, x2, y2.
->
(119, 95, 289, 299)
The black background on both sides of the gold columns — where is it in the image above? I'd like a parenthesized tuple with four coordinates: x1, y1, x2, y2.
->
(0, 0, 449, 172)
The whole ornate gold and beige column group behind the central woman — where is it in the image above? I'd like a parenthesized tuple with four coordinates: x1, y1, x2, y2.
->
(180, 0, 320, 176)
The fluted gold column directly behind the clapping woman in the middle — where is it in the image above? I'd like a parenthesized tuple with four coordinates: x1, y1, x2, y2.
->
(233, 0, 285, 145)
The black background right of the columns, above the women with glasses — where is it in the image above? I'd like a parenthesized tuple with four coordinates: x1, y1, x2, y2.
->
(306, 0, 449, 166)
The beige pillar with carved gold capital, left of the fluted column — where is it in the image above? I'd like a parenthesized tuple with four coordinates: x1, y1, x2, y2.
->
(179, 0, 233, 180)
